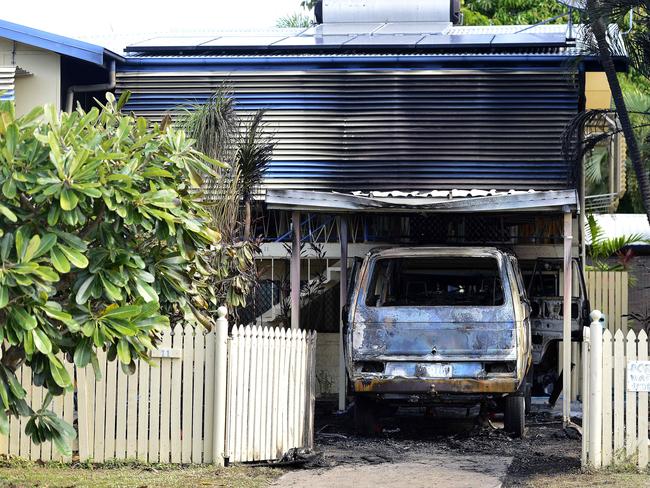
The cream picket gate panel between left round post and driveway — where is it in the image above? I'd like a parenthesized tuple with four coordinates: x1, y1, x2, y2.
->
(225, 326, 316, 462)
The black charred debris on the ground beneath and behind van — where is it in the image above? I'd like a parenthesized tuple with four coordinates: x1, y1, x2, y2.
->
(305, 400, 581, 486)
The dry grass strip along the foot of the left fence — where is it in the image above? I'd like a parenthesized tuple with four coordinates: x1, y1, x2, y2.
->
(0, 459, 282, 488)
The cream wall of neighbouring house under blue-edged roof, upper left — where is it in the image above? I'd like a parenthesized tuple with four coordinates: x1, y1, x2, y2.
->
(0, 39, 61, 115)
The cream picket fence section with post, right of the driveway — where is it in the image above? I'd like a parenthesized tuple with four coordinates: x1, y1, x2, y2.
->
(581, 312, 650, 470)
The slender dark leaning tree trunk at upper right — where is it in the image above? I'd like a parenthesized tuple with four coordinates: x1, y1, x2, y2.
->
(587, 0, 650, 222)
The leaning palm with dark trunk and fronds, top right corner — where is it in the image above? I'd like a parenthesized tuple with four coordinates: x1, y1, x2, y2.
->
(585, 0, 650, 222)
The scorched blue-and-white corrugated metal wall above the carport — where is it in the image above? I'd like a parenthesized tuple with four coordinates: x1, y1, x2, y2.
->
(117, 66, 578, 191)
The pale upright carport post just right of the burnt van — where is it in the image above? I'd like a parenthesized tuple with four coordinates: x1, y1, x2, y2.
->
(562, 207, 573, 427)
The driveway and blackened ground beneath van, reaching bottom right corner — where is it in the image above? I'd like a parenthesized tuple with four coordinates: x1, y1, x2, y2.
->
(274, 402, 650, 488)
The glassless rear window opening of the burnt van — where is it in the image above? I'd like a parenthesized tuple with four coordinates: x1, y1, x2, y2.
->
(366, 257, 504, 307)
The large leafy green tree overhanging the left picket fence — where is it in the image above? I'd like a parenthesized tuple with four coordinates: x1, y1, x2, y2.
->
(0, 93, 228, 452)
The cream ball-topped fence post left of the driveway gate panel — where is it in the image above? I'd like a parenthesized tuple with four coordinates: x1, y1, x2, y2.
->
(212, 306, 228, 466)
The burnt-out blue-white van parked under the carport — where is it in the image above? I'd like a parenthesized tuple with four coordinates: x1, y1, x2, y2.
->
(344, 247, 532, 435)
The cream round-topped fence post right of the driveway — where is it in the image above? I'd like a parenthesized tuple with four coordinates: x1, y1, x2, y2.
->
(588, 310, 605, 468)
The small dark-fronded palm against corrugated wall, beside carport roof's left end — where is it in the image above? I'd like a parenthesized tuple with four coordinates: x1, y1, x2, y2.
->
(233, 110, 274, 240)
